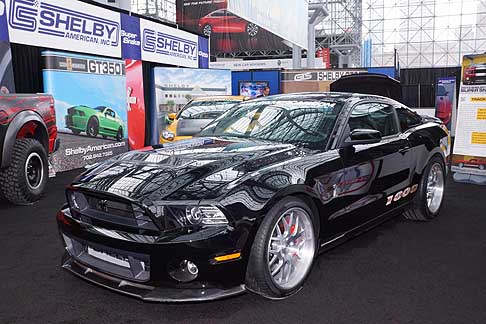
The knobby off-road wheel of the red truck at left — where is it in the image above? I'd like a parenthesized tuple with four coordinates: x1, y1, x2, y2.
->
(0, 138, 49, 204)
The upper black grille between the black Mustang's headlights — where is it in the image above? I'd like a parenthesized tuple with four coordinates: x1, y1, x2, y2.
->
(67, 191, 160, 235)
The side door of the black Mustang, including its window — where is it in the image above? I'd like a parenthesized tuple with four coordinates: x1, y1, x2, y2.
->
(330, 99, 413, 232)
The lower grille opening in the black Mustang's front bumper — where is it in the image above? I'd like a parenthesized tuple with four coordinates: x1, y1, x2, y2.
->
(63, 234, 150, 282)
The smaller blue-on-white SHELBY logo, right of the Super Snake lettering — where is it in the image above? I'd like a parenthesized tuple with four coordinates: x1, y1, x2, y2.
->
(142, 28, 197, 61)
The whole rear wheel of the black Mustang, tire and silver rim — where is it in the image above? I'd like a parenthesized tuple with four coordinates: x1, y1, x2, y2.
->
(403, 156, 446, 221)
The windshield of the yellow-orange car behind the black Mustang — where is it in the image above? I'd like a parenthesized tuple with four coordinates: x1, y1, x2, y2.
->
(177, 100, 239, 119)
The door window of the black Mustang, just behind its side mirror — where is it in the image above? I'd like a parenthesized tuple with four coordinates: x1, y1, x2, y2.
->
(348, 102, 398, 137)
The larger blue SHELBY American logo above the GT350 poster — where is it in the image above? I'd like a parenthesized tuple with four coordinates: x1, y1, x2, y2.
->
(8, 0, 120, 47)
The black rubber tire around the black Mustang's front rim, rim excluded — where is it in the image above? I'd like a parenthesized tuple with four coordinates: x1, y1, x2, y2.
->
(245, 197, 319, 299)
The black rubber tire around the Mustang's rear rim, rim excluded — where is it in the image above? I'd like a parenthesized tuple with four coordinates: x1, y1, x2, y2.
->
(403, 156, 446, 221)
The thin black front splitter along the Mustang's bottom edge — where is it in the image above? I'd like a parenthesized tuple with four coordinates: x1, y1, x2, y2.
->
(62, 256, 246, 303)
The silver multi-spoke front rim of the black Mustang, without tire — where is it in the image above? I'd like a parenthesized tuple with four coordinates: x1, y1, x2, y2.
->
(267, 207, 316, 289)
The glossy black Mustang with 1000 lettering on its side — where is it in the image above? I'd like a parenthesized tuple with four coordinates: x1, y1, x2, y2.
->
(57, 93, 449, 302)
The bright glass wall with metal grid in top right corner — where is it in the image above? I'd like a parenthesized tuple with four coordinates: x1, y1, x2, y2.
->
(363, 0, 486, 68)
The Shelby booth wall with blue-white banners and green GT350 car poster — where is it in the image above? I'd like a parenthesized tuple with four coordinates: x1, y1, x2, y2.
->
(0, 0, 209, 171)
